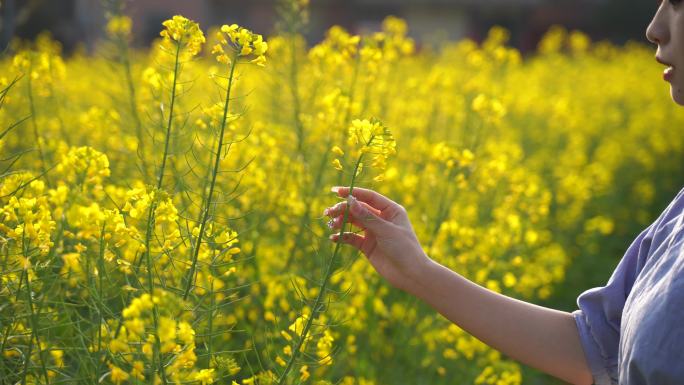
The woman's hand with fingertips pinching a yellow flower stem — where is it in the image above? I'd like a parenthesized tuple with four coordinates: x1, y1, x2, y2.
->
(324, 187, 430, 291)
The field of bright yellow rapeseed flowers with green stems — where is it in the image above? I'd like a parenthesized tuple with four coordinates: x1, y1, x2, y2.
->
(0, 2, 684, 385)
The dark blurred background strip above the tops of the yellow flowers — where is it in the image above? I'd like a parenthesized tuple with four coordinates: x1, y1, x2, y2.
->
(0, 0, 656, 53)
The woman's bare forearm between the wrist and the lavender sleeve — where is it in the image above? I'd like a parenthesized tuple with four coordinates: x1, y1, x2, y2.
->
(407, 260, 592, 384)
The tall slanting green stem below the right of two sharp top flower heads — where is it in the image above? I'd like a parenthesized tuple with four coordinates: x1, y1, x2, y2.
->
(183, 52, 238, 300)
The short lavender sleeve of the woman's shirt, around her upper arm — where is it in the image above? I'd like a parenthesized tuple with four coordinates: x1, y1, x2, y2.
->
(572, 225, 653, 385)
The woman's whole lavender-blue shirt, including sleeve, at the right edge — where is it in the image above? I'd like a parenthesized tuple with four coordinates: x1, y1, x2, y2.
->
(572, 184, 684, 385)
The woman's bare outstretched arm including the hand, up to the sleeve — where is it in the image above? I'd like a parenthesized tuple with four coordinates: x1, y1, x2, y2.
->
(325, 187, 593, 385)
